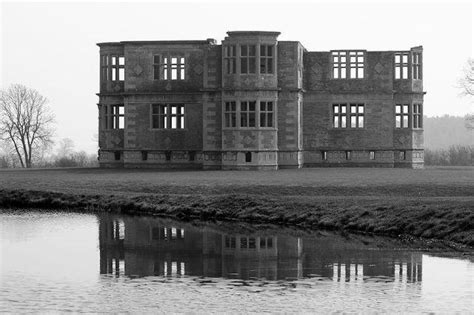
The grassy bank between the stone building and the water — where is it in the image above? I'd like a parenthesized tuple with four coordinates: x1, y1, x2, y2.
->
(0, 168, 474, 246)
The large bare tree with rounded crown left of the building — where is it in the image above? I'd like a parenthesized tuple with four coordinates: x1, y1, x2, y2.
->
(0, 84, 54, 168)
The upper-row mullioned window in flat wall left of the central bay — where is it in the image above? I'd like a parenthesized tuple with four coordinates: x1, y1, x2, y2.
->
(153, 55, 186, 81)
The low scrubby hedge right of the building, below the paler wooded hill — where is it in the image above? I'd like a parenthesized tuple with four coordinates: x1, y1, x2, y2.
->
(425, 145, 474, 166)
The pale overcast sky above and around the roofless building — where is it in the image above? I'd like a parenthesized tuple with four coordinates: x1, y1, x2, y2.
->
(0, 0, 474, 153)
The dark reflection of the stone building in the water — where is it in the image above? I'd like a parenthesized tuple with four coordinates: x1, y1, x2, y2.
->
(99, 214, 422, 282)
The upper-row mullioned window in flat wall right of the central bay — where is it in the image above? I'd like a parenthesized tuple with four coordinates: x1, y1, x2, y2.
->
(331, 51, 365, 79)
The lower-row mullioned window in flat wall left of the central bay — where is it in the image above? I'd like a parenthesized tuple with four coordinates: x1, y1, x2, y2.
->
(151, 104, 185, 129)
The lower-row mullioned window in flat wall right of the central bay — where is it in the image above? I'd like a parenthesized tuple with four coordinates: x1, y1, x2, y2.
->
(332, 104, 365, 128)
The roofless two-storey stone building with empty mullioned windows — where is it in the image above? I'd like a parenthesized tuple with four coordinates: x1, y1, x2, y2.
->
(98, 31, 425, 169)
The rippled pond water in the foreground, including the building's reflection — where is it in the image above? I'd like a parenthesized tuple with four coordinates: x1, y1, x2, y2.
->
(0, 211, 474, 313)
